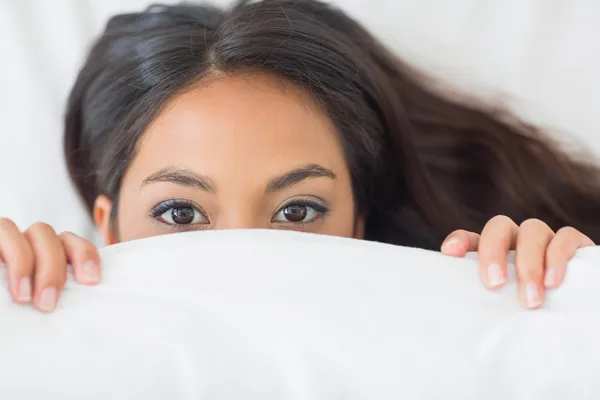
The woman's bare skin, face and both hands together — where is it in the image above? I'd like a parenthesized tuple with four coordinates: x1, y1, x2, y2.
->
(0, 74, 594, 312)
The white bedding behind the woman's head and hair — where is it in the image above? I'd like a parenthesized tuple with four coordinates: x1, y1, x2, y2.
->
(0, 0, 600, 235)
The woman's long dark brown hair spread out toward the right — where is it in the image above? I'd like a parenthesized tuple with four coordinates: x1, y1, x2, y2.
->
(64, 0, 600, 249)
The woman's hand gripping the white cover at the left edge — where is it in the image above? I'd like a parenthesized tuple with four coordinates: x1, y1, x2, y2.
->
(0, 218, 100, 312)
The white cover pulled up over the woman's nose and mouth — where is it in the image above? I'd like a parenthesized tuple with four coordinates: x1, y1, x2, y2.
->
(0, 230, 600, 400)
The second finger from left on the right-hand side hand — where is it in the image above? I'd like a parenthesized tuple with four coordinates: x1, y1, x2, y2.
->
(477, 215, 519, 289)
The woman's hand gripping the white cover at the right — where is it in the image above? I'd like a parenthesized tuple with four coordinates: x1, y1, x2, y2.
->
(442, 215, 595, 309)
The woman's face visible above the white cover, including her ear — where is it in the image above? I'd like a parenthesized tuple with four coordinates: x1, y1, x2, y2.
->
(94, 74, 362, 244)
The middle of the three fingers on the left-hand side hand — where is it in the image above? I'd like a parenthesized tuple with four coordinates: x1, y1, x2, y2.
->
(25, 223, 67, 312)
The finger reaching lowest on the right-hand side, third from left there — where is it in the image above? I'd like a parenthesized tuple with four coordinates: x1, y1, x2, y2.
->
(515, 219, 554, 309)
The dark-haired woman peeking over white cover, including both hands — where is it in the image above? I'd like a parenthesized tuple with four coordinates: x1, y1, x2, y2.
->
(0, 0, 600, 311)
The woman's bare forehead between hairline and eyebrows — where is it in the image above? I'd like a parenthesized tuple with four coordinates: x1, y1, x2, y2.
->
(131, 74, 345, 182)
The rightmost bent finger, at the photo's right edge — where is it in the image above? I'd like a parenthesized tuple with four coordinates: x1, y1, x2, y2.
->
(544, 227, 595, 288)
